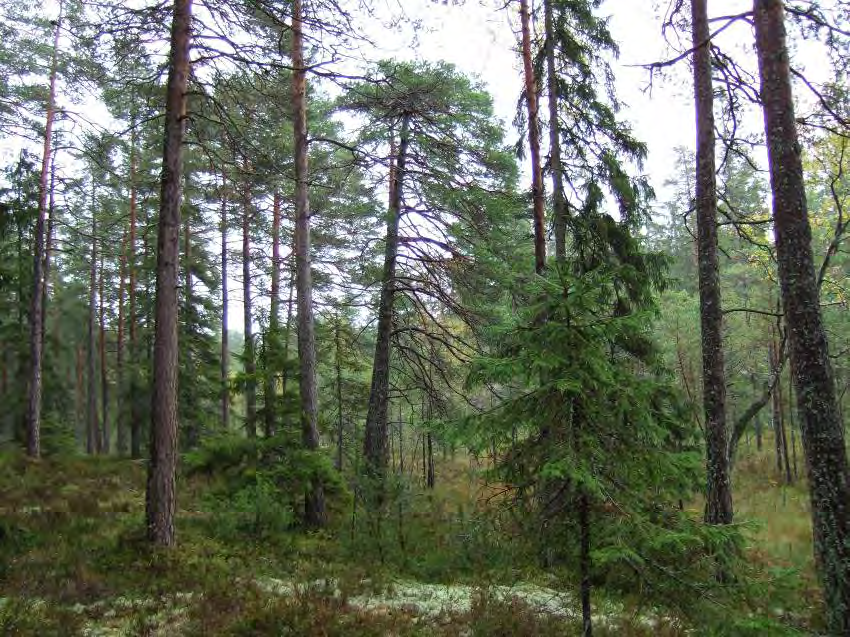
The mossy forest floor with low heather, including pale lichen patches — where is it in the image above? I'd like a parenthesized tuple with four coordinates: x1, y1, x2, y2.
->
(0, 444, 817, 636)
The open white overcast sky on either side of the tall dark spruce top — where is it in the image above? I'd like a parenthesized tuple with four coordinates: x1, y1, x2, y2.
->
(372, 0, 752, 199)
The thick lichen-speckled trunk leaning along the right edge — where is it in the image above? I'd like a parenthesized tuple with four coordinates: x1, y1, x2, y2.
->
(753, 0, 850, 635)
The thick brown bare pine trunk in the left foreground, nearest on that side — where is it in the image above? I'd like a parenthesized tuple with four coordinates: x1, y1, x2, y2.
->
(145, 0, 192, 547)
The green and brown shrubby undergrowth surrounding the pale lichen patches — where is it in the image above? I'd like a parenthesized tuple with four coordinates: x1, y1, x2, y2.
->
(0, 442, 819, 636)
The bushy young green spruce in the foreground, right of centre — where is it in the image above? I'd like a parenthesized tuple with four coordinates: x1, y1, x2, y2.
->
(463, 266, 739, 606)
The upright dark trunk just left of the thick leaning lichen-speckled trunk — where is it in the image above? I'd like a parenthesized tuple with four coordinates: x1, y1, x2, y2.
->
(691, 0, 732, 524)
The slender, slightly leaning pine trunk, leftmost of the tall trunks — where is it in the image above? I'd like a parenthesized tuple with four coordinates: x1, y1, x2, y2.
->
(26, 2, 63, 458)
